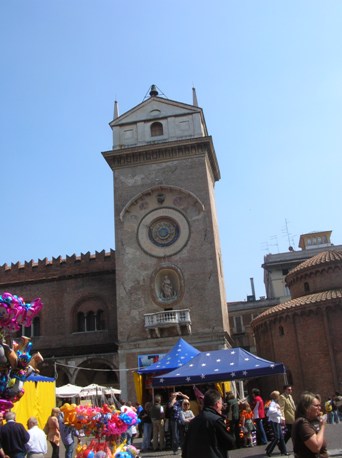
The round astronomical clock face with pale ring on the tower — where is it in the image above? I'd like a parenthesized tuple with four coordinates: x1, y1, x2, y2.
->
(137, 207, 190, 258)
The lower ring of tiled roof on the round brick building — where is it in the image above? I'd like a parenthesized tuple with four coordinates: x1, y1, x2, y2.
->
(252, 288, 342, 327)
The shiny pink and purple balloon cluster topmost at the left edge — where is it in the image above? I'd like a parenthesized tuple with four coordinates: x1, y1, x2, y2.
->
(0, 293, 43, 331)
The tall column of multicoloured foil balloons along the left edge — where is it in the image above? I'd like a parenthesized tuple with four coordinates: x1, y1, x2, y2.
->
(0, 292, 43, 413)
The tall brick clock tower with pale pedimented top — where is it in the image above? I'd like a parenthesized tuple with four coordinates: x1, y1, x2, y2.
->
(103, 85, 229, 396)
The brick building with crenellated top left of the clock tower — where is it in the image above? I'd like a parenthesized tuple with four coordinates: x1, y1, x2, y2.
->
(0, 250, 118, 383)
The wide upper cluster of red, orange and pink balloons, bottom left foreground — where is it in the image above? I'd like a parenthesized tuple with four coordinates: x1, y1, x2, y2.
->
(60, 403, 140, 439)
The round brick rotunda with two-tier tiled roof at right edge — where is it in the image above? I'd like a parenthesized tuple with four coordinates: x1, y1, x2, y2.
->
(252, 250, 342, 398)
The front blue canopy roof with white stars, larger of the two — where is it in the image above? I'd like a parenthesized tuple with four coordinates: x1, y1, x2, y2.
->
(152, 347, 286, 388)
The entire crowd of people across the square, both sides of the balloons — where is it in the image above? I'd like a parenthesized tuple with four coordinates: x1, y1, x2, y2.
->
(0, 385, 336, 458)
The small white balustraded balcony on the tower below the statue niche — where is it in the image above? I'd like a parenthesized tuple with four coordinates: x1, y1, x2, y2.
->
(144, 309, 191, 337)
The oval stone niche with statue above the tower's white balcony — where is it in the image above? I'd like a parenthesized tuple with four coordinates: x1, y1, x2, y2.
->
(151, 264, 184, 309)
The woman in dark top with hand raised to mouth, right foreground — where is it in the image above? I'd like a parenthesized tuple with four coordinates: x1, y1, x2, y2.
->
(292, 392, 328, 458)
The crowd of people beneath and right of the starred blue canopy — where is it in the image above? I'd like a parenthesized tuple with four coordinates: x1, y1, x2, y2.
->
(134, 385, 336, 458)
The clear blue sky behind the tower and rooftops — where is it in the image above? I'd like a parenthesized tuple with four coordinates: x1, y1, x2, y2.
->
(0, 0, 342, 301)
